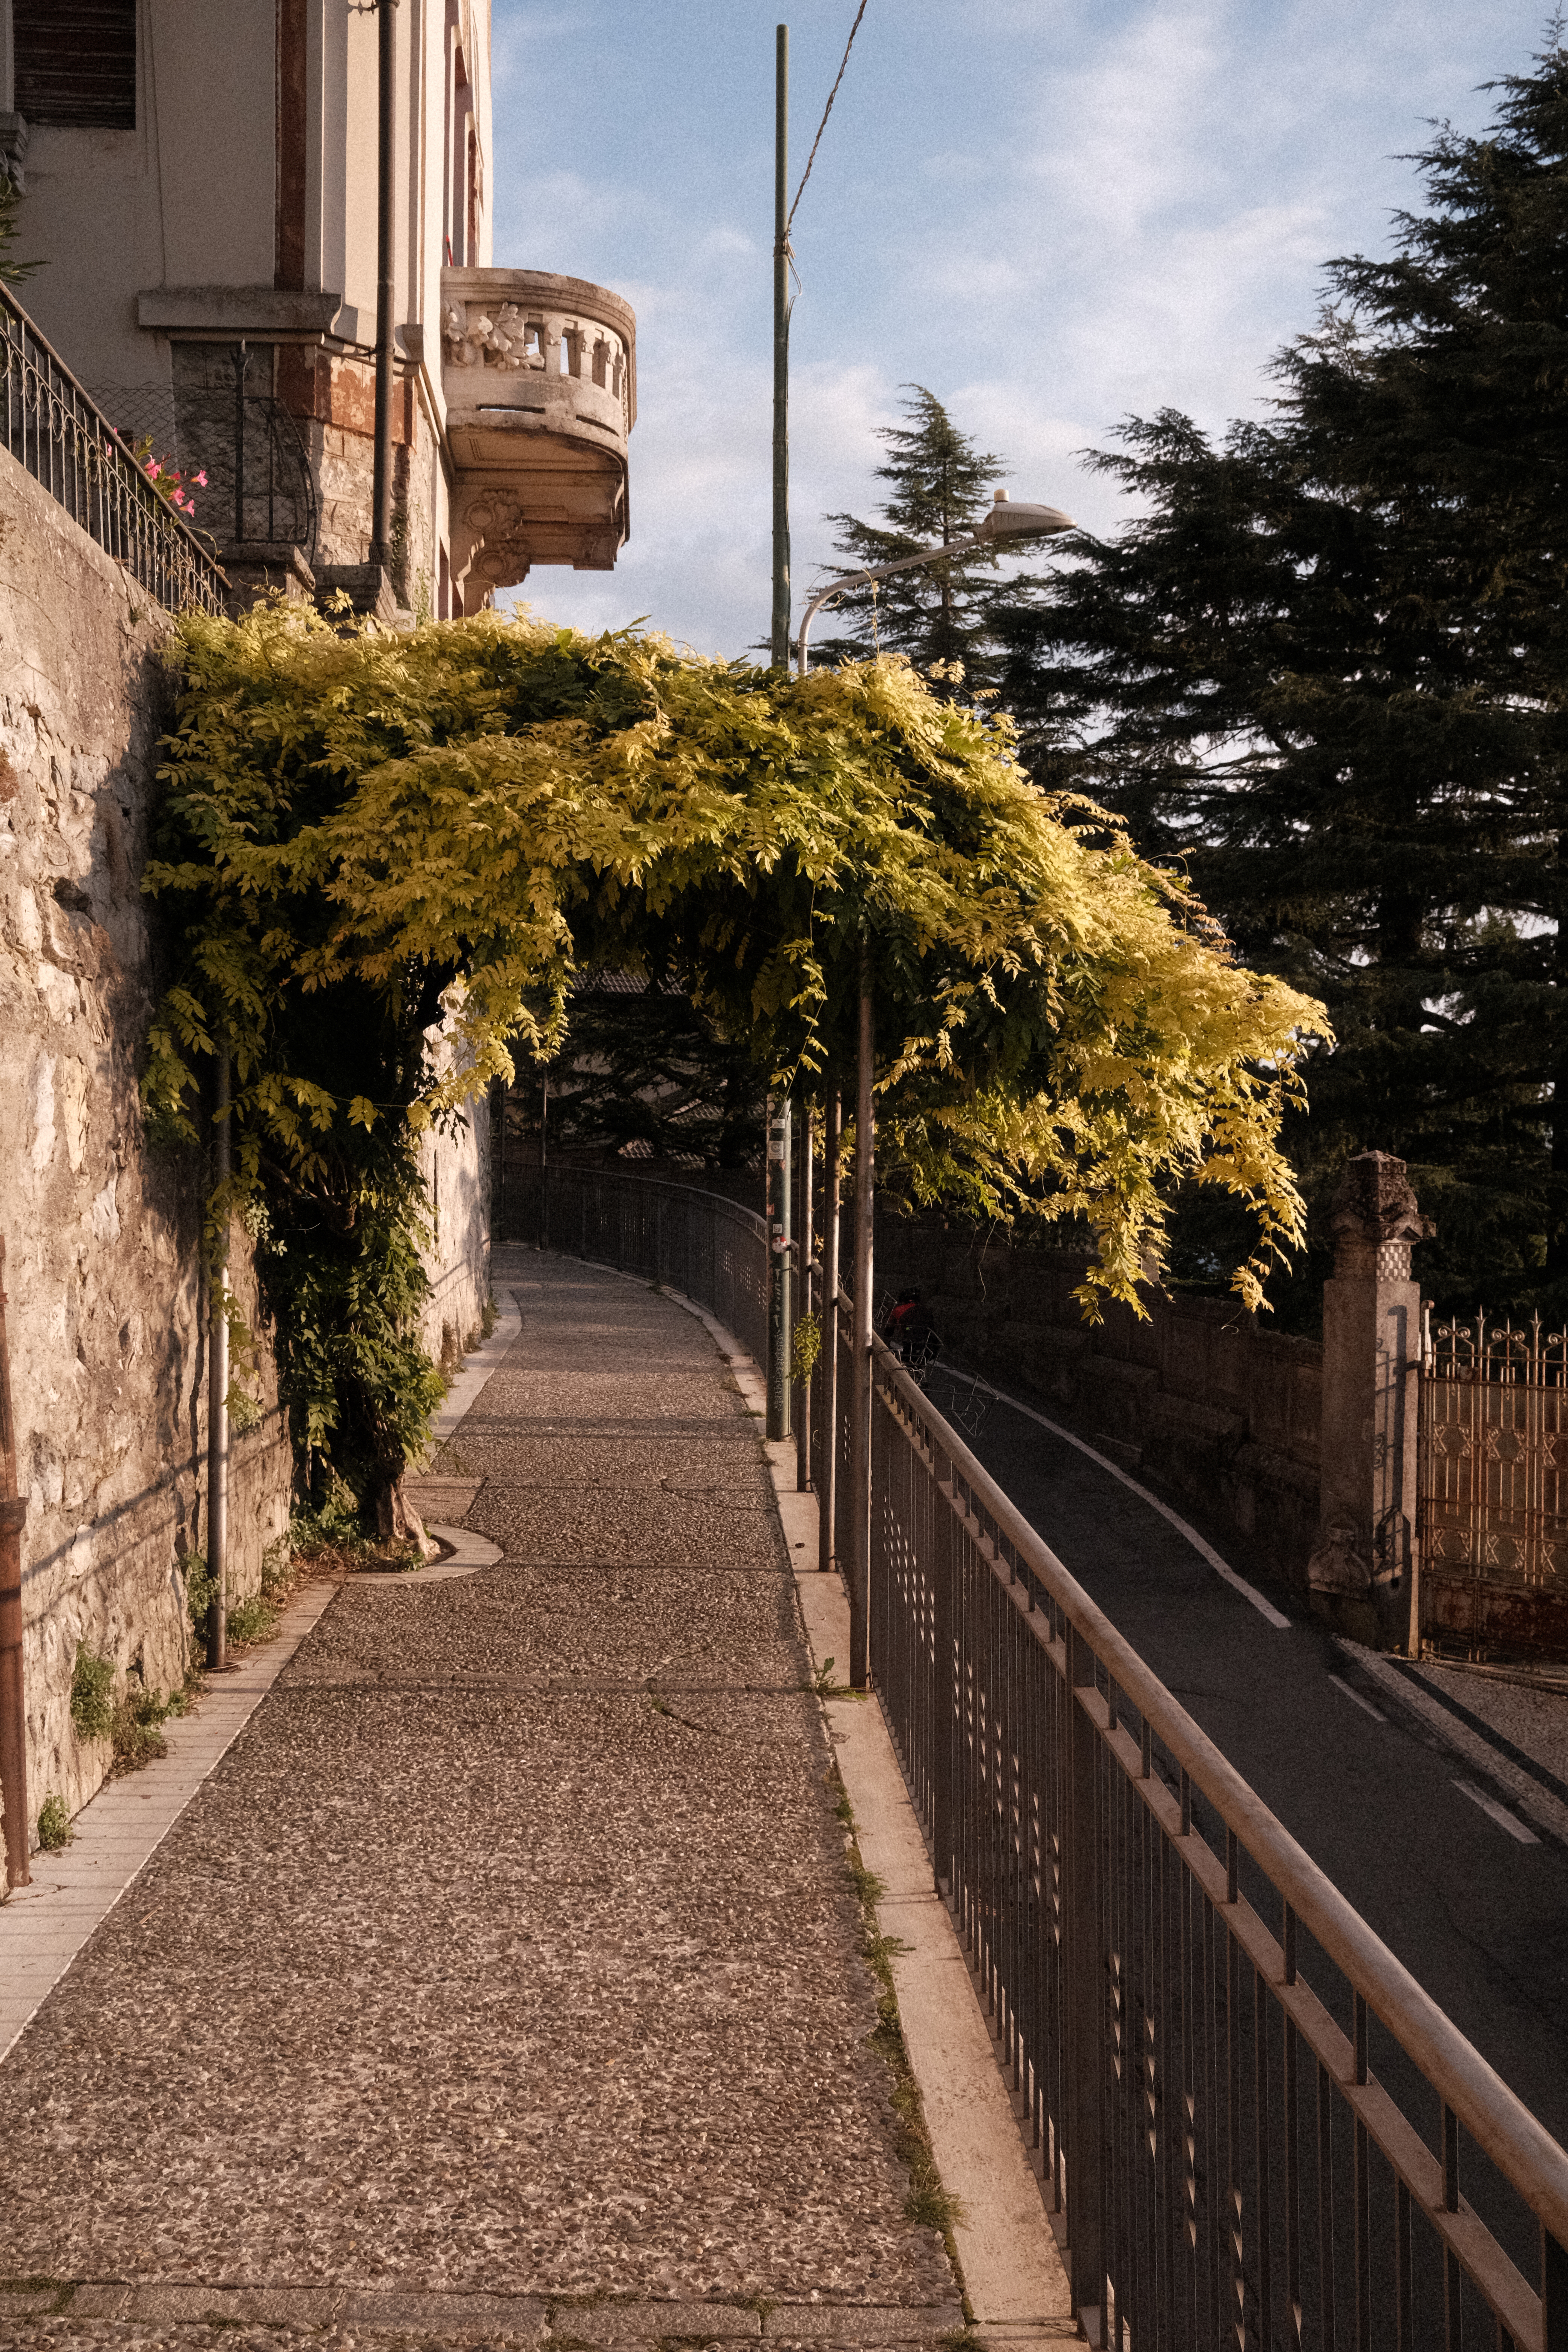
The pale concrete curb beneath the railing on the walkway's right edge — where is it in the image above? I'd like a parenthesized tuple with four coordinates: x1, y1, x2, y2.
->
(611, 1268, 1081, 2352)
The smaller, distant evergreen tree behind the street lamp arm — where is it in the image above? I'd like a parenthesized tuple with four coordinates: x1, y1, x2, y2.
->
(813, 383, 1004, 696)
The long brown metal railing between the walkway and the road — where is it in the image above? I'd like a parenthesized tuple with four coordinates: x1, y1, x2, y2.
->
(536, 1169, 1568, 2352)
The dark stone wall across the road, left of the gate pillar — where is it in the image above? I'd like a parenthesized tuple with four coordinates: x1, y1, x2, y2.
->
(877, 1216, 1323, 1588)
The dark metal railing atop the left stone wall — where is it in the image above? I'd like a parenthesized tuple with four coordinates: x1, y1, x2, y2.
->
(0, 287, 228, 614)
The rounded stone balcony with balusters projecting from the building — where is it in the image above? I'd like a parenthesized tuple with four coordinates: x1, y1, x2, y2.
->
(442, 271, 637, 590)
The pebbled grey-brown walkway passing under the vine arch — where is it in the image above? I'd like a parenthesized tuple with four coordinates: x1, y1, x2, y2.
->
(0, 1258, 983, 2352)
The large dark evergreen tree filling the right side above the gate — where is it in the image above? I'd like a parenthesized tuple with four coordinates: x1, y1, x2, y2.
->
(992, 49, 1568, 1320)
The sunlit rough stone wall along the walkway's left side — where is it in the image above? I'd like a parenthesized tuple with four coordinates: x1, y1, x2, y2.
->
(0, 454, 289, 1821)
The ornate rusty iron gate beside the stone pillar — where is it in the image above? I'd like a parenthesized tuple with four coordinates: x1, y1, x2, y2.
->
(1418, 1308, 1568, 1658)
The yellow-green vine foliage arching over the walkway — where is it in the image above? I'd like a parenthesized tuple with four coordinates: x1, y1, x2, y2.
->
(146, 605, 1323, 1298)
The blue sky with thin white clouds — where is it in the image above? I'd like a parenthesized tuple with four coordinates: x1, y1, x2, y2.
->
(494, 0, 1545, 654)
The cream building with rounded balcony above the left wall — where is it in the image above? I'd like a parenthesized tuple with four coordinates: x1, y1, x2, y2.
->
(0, 0, 637, 616)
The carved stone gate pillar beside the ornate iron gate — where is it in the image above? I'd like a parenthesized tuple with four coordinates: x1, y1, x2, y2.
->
(1307, 1153, 1434, 1649)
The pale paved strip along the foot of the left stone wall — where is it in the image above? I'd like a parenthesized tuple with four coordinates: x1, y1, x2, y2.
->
(0, 1576, 338, 2060)
